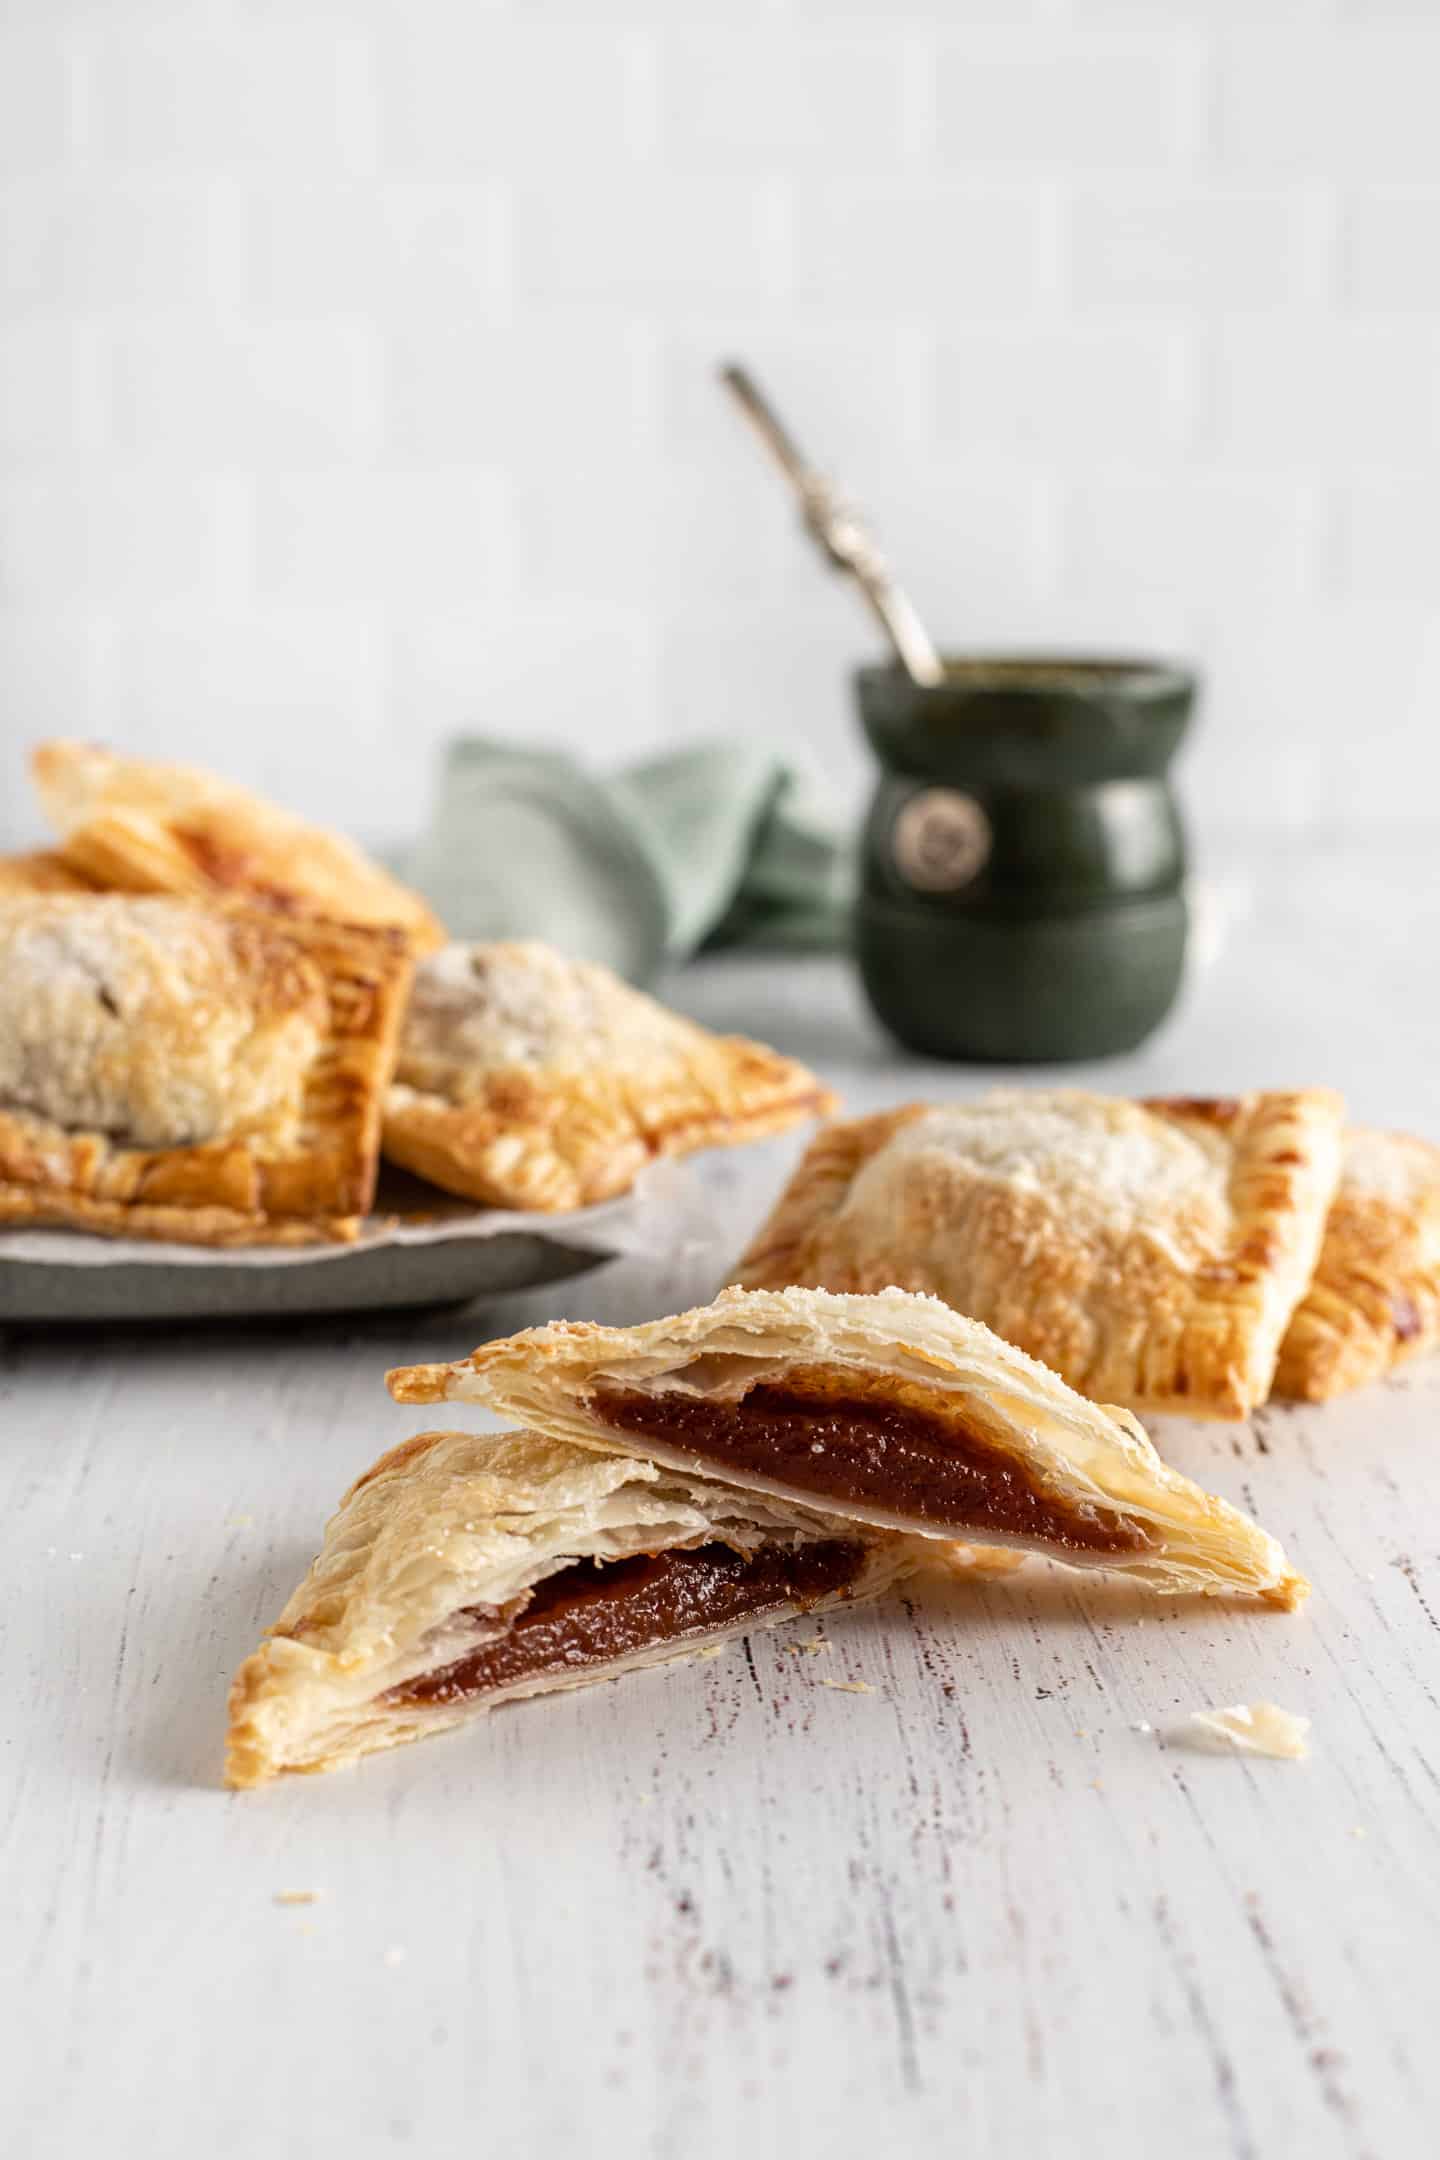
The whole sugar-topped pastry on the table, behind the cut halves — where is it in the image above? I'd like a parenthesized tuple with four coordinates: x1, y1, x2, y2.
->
(736, 1089, 1343, 1417)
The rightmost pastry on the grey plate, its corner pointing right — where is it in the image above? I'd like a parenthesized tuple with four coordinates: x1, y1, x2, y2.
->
(384, 940, 836, 1210)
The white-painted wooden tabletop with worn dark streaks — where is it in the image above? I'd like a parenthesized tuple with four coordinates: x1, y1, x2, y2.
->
(0, 847, 1440, 2160)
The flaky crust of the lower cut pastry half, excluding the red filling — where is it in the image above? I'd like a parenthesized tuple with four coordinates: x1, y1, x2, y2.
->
(225, 1432, 928, 1786)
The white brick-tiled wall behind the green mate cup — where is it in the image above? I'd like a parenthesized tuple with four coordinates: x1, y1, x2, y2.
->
(0, 0, 1440, 838)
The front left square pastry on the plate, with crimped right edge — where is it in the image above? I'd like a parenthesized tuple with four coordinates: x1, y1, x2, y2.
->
(0, 892, 412, 1244)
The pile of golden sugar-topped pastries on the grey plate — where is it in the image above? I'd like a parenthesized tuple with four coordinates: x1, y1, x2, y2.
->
(0, 743, 833, 1244)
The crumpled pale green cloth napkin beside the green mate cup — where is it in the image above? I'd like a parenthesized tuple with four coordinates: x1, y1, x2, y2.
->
(406, 737, 851, 983)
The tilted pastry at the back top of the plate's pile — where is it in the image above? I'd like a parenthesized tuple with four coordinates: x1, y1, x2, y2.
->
(30, 741, 445, 953)
